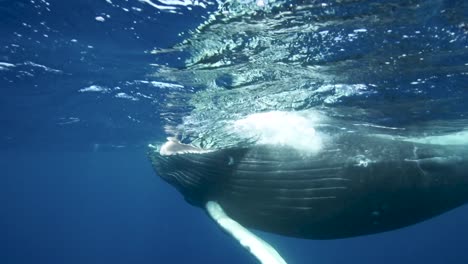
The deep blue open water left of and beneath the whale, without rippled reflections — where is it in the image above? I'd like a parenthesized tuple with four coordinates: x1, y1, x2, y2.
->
(0, 0, 468, 264)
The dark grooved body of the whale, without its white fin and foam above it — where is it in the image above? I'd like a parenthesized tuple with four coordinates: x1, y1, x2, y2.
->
(150, 135, 468, 239)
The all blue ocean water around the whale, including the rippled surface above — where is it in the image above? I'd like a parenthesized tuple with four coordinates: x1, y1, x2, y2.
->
(0, 0, 468, 263)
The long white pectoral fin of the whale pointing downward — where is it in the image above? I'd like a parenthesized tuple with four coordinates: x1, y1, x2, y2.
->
(206, 201, 286, 264)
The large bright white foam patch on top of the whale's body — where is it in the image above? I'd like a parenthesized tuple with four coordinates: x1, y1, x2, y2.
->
(231, 111, 325, 153)
